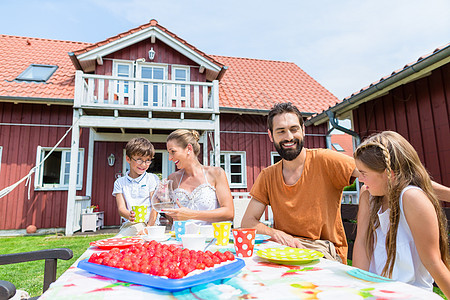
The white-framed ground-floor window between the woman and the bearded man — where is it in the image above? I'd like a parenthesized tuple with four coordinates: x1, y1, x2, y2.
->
(210, 151, 247, 188)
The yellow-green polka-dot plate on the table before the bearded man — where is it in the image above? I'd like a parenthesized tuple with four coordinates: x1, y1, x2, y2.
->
(256, 247, 323, 265)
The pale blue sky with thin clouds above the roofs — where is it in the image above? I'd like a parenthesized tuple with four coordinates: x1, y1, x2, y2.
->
(0, 0, 450, 99)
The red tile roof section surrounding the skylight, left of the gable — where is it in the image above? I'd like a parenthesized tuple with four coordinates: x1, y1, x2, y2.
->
(0, 35, 89, 99)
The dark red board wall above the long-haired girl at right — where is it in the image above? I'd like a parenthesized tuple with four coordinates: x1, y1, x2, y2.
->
(353, 64, 450, 192)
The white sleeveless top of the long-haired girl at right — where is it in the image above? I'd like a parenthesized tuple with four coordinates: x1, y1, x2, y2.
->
(369, 185, 433, 291)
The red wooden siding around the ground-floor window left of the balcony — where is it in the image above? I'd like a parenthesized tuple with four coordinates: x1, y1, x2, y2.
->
(0, 102, 89, 230)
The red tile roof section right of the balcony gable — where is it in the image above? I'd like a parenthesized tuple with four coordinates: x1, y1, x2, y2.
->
(212, 55, 339, 112)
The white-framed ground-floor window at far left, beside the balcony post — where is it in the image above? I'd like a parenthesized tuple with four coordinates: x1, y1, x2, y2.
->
(34, 147, 84, 190)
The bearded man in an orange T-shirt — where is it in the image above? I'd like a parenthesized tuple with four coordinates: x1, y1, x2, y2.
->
(242, 102, 358, 263)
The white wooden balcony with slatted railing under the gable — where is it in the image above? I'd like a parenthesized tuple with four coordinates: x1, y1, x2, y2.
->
(74, 71, 219, 127)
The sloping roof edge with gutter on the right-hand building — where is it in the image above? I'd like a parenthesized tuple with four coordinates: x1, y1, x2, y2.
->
(305, 45, 450, 126)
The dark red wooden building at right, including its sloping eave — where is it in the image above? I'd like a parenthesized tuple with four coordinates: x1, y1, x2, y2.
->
(306, 44, 450, 205)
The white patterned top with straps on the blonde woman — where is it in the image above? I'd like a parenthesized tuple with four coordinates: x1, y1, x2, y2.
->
(173, 168, 219, 225)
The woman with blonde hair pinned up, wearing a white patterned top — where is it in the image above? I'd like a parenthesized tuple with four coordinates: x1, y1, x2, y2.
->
(164, 129, 234, 224)
